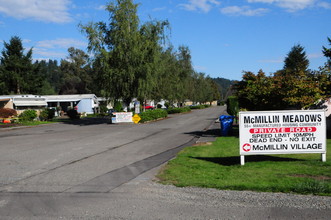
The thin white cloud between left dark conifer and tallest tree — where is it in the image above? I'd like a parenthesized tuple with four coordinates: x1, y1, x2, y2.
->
(36, 38, 87, 49)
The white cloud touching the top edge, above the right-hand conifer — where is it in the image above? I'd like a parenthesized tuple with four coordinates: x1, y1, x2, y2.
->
(247, 0, 331, 12)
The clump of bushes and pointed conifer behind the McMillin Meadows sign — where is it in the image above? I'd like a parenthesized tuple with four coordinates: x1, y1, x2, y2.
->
(234, 45, 330, 110)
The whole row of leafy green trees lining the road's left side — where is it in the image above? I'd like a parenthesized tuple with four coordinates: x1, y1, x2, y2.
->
(80, 0, 219, 106)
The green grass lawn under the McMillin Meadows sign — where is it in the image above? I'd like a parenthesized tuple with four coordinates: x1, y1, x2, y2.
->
(158, 137, 331, 196)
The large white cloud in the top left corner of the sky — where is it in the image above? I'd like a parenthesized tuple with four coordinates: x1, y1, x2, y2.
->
(0, 0, 72, 23)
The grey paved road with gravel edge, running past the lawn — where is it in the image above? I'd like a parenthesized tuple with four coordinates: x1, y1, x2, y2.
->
(0, 107, 331, 219)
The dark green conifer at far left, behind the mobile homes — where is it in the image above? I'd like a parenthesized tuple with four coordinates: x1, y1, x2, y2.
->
(0, 36, 38, 94)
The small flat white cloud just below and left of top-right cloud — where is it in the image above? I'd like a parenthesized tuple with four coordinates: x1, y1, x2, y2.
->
(221, 6, 269, 16)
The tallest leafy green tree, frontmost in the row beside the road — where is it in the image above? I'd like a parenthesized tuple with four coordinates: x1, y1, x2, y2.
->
(81, 0, 141, 104)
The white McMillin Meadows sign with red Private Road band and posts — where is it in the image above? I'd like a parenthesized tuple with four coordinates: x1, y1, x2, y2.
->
(239, 110, 326, 165)
